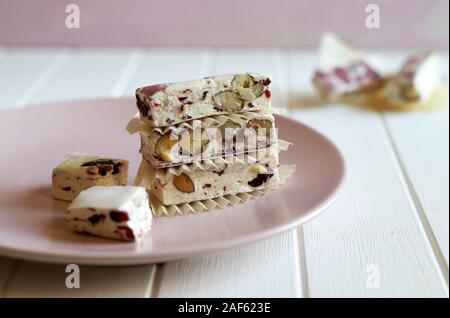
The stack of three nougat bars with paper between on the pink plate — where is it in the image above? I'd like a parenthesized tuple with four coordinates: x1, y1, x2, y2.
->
(128, 73, 279, 206)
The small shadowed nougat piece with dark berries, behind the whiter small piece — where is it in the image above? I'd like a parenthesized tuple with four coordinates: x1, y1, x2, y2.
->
(52, 155, 128, 201)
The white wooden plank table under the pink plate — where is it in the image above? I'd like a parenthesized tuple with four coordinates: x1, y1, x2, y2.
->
(0, 47, 449, 297)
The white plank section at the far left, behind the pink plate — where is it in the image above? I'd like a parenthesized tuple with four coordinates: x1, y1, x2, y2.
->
(0, 48, 74, 110)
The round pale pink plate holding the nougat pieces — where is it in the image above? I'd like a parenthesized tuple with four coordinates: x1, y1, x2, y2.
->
(0, 99, 345, 265)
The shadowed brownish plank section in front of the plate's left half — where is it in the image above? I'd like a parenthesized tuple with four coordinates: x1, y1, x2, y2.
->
(5, 262, 155, 298)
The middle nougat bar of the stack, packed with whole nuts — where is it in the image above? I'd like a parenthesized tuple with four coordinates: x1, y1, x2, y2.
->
(140, 111, 277, 168)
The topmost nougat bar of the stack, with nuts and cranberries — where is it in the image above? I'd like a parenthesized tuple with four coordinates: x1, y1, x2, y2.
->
(136, 73, 271, 127)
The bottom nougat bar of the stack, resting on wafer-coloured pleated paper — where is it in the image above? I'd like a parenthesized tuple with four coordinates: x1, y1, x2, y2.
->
(141, 147, 279, 205)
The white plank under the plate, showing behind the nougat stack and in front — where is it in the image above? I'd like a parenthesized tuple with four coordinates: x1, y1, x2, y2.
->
(158, 49, 302, 297)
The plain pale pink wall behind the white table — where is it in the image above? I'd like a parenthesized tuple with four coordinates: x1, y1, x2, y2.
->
(0, 0, 449, 48)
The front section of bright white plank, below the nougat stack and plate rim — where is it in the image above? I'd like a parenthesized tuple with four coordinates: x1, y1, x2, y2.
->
(158, 232, 301, 297)
